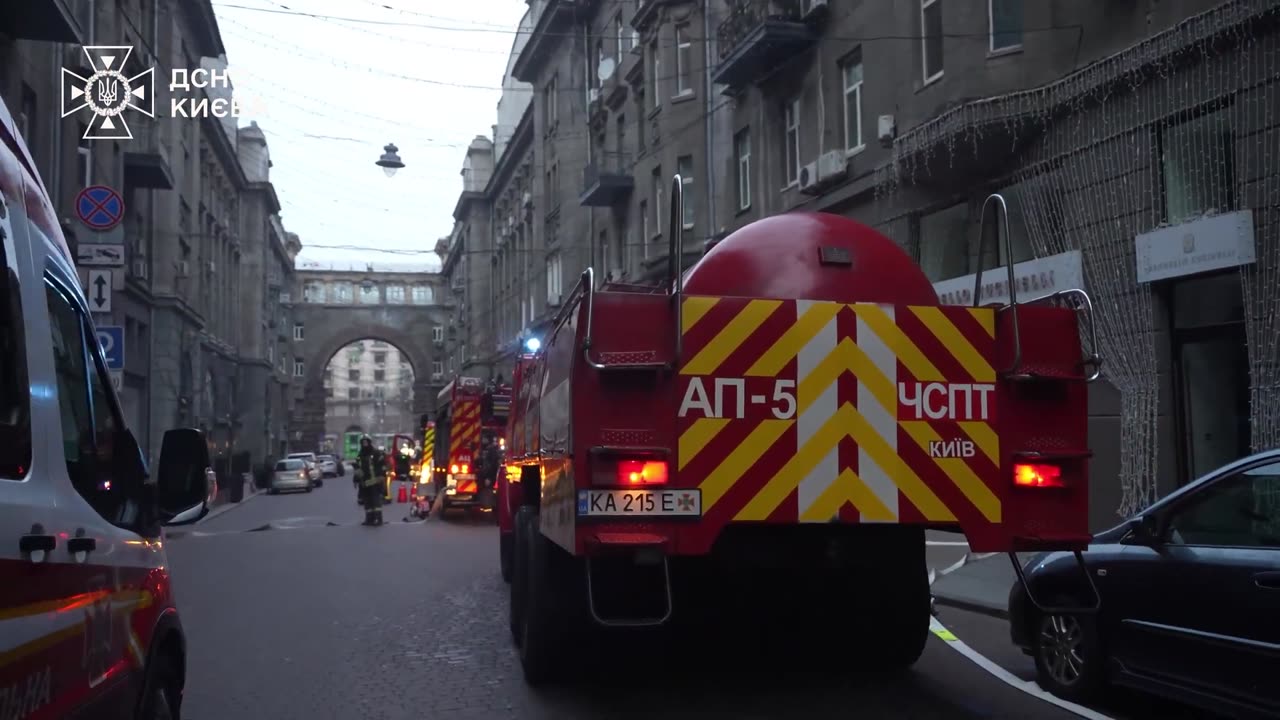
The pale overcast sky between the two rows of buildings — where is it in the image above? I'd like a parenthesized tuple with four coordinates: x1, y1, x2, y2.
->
(212, 0, 529, 269)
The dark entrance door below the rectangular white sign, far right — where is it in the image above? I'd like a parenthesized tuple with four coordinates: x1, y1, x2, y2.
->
(1172, 272, 1251, 484)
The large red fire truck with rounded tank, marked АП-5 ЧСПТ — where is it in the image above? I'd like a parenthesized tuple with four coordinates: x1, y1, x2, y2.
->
(509, 176, 1101, 684)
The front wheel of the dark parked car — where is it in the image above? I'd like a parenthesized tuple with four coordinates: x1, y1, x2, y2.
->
(1034, 604, 1106, 702)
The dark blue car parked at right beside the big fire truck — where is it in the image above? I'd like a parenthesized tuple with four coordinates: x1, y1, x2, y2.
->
(1009, 450, 1280, 717)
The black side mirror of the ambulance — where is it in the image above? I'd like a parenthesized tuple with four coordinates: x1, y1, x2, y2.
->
(156, 428, 218, 525)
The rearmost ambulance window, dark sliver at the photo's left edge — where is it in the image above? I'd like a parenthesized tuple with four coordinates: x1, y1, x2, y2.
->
(0, 206, 31, 479)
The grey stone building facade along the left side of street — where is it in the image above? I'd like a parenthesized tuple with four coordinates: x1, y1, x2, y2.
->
(0, 0, 298, 470)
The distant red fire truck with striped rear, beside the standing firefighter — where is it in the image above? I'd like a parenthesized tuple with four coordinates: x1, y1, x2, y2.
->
(435, 377, 511, 510)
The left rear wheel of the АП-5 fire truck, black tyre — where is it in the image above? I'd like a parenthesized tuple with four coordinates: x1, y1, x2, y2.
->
(520, 509, 586, 687)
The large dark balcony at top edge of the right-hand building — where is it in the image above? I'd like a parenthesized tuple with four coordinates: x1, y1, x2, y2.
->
(712, 0, 818, 90)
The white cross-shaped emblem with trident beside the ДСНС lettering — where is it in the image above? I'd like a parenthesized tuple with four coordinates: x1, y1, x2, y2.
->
(63, 45, 156, 140)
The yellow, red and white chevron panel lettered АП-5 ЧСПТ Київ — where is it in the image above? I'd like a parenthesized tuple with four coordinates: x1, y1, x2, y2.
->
(677, 296, 1002, 523)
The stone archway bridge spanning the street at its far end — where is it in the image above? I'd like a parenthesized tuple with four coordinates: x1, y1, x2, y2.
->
(291, 270, 448, 451)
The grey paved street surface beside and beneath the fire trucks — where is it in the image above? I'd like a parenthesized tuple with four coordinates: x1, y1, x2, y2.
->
(160, 478, 1162, 720)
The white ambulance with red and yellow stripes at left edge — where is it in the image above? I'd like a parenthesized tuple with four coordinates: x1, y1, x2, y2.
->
(0, 102, 216, 720)
